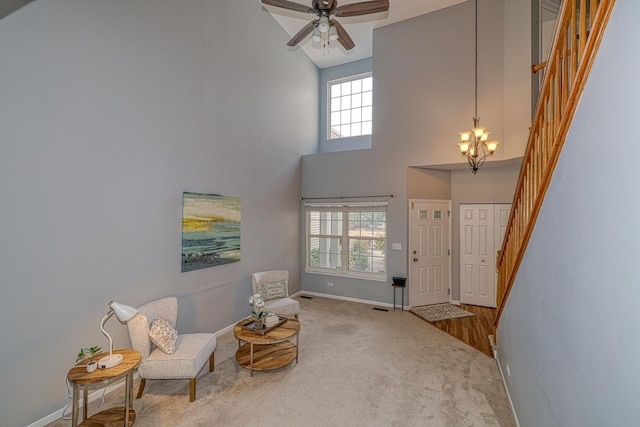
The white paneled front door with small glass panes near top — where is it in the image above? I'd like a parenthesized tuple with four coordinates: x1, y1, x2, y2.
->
(408, 200, 451, 307)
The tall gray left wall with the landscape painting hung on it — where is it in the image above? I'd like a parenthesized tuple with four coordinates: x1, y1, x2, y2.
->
(0, 0, 319, 426)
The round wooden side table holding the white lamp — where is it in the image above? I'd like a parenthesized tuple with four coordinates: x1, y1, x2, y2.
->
(67, 350, 142, 427)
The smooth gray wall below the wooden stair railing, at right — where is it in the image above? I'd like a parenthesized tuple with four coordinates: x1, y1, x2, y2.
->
(498, 0, 640, 427)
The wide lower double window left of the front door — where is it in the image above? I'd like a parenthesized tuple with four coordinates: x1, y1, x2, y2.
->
(305, 203, 387, 280)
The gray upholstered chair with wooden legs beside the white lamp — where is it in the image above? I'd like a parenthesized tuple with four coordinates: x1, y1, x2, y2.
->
(127, 296, 216, 402)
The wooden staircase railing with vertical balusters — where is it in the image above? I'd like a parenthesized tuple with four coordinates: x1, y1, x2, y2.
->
(493, 0, 615, 340)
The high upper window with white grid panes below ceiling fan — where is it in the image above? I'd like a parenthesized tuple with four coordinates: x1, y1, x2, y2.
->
(329, 73, 373, 139)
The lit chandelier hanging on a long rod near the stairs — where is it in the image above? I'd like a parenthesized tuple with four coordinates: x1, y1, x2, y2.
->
(458, 0, 498, 175)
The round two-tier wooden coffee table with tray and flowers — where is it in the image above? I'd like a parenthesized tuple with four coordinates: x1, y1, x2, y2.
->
(233, 315, 300, 376)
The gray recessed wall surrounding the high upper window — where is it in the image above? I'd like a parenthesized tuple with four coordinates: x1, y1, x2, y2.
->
(318, 58, 375, 153)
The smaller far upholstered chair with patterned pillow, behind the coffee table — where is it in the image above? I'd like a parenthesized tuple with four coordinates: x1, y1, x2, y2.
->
(251, 270, 300, 318)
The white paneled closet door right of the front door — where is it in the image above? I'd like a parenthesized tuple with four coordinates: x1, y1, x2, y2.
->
(460, 204, 511, 308)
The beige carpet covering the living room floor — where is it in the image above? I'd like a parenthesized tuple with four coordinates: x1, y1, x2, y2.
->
(50, 297, 515, 427)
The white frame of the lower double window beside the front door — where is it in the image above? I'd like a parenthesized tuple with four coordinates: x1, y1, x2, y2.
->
(304, 202, 389, 282)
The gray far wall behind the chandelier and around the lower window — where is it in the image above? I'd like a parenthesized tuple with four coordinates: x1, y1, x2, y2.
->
(302, 0, 531, 304)
